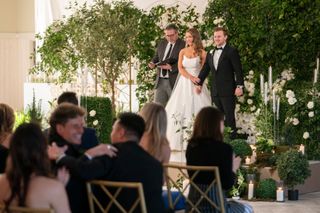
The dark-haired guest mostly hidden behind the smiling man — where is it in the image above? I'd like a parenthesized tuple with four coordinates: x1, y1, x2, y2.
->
(46, 92, 99, 152)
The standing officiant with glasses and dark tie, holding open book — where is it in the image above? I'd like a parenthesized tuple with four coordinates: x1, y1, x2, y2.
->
(149, 24, 186, 106)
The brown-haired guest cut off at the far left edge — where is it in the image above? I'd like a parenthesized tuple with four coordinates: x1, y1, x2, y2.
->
(0, 103, 15, 173)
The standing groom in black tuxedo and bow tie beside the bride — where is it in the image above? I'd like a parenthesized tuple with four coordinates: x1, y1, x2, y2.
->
(197, 27, 243, 138)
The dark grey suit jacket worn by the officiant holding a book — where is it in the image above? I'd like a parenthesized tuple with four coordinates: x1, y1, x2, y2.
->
(152, 38, 186, 88)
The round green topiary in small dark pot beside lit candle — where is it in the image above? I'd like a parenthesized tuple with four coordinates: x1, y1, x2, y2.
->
(277, 149, 311, 200)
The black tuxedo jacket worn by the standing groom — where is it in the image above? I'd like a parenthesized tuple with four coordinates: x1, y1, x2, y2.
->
(198, 44, 243, 97)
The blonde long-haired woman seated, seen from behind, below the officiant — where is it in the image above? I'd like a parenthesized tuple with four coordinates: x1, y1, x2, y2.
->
(139, 103, 171, 163)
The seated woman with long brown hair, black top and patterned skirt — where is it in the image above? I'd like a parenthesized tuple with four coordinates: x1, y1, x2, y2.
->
(186, 107, 253, 213)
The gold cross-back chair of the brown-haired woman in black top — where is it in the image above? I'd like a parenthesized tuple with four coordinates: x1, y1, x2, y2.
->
(163, 164, 225, 213)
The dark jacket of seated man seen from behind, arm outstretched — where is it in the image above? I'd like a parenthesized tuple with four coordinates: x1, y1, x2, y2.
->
(59, 141, 164, 213)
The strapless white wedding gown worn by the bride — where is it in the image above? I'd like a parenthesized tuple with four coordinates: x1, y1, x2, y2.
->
(166, 56, 212, 162)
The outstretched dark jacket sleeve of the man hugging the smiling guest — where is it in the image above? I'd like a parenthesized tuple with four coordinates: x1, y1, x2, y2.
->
(58, 155, 111, 180)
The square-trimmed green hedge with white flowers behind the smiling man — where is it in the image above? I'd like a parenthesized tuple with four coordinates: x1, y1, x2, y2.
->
(80, 96, 113, 143)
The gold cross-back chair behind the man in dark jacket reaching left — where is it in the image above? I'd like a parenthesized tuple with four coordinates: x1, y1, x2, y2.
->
(87, 180, 147, 213)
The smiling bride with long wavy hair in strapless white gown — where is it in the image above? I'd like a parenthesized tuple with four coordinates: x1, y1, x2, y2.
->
(166, 28, 211, 162)
